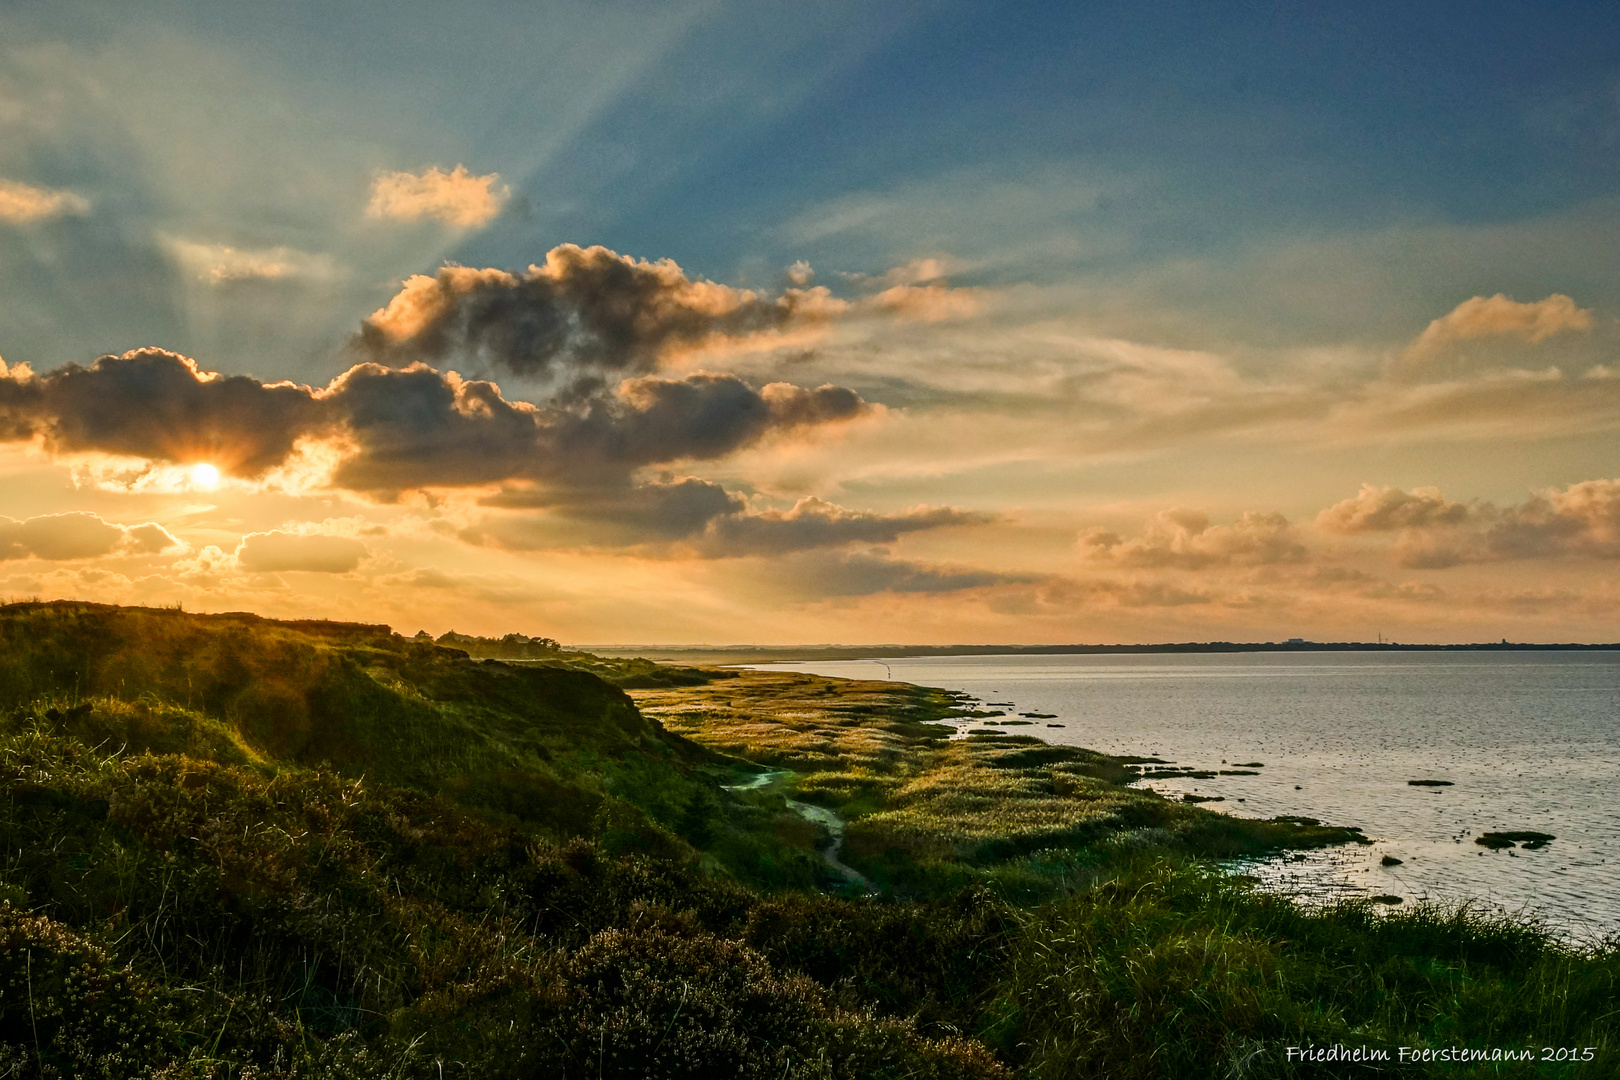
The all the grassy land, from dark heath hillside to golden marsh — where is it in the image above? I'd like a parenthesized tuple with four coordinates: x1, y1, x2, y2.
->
(0, 604, 1620, 1080)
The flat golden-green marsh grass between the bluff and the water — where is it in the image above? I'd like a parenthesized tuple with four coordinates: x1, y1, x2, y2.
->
(632, 672, 1358, 902)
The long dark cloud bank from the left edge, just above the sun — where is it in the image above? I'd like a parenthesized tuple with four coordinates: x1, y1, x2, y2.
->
(0, 350, 865, 497)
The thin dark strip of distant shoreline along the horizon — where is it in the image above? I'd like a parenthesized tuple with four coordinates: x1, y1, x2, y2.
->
(577, 641, 1620, 664)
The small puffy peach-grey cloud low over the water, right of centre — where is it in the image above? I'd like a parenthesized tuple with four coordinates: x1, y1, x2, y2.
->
(1079, 510, 1309, 570)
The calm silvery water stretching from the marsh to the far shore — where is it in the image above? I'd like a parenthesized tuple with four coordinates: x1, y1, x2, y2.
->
(751, 653, 1620, 938)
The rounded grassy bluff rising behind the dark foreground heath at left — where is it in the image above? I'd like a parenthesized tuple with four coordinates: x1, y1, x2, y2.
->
(0, 602, 745, 837)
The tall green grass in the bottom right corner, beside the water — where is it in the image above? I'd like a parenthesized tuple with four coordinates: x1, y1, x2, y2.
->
(988, 860, 1620, 1077)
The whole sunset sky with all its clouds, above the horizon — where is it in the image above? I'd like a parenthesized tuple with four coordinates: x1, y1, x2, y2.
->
(0, 0, 1620, 644)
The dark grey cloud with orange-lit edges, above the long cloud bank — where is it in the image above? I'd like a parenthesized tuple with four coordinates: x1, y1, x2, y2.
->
(358, 244, 847, 377)
